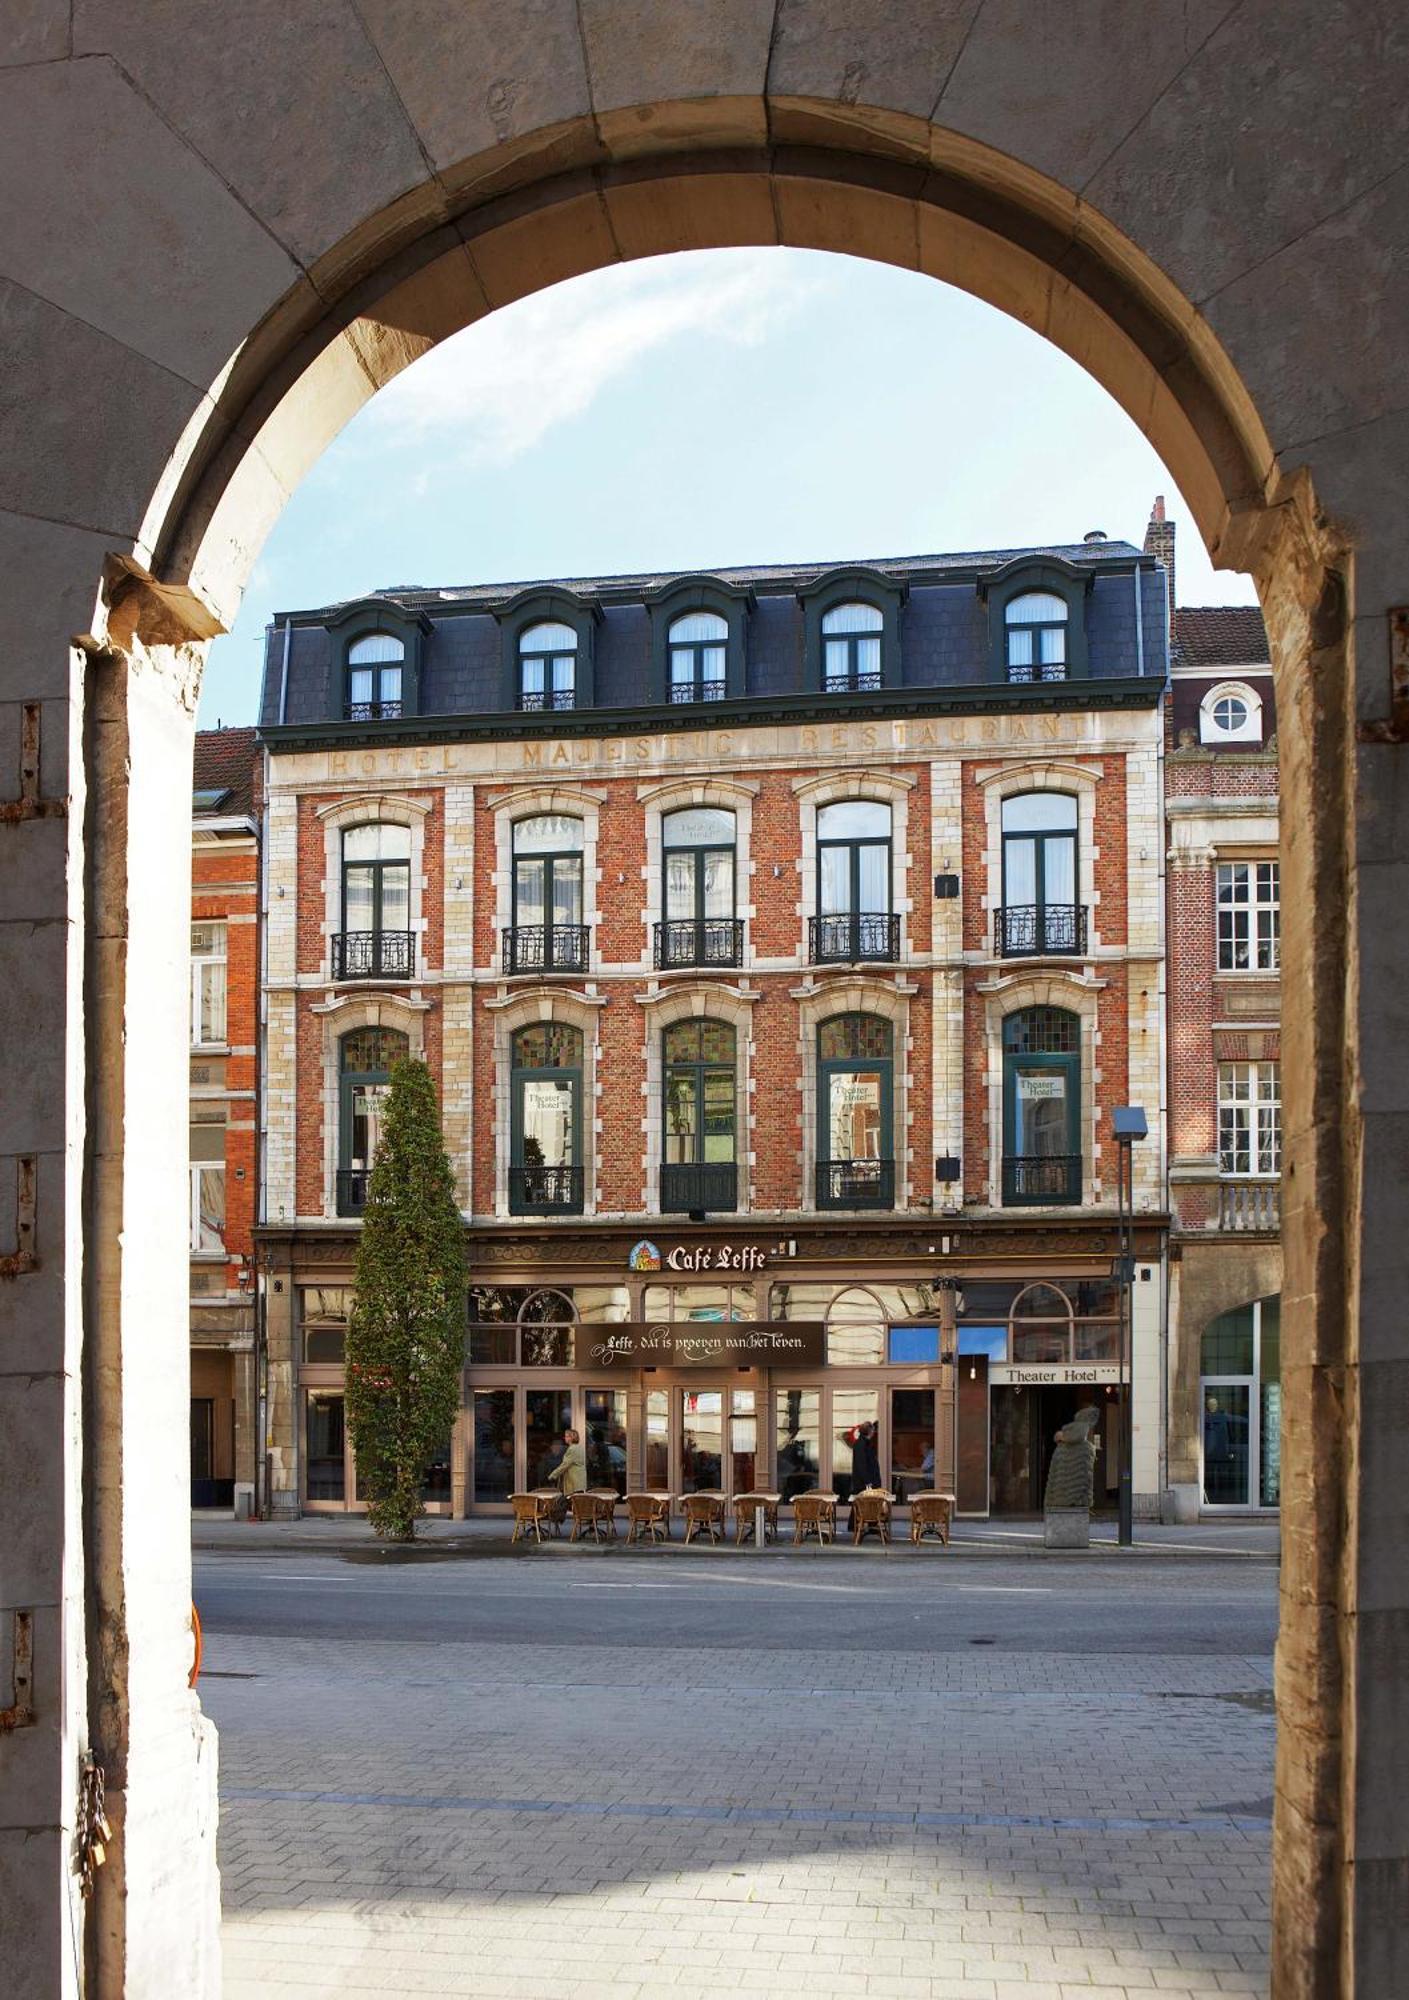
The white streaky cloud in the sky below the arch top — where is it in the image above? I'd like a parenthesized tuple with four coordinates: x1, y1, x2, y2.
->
(368, 250, 819, 466)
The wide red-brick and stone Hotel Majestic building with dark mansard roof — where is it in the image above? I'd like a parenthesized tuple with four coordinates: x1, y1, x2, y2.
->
(250, 536, 1167, 1514)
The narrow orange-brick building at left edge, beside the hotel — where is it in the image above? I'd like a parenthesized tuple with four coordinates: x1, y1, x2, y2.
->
(190, 730, 262, 1506)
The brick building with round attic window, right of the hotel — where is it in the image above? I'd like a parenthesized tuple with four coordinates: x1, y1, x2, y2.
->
(1145, 502, 1281, 1512)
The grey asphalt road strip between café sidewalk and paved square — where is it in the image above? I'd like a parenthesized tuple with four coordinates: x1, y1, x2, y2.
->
(194, 1554, 1277, 1666)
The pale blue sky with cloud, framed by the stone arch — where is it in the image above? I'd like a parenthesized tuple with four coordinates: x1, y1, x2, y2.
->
(200, 248, 1255, 728)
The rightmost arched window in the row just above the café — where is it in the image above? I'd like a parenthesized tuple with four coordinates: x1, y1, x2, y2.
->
(1003, 1006, 1081, 1206)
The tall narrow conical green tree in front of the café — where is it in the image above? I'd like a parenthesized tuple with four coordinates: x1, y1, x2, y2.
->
(346, 1062, 466, 1542)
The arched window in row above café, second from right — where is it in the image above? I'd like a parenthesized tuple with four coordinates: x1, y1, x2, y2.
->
(817, 1014, 895, 1208)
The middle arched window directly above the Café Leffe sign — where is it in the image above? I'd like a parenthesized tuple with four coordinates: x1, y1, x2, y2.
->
(660, 1020, 739, 1214)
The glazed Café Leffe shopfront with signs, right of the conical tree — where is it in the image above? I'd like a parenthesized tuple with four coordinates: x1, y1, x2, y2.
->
(464, 1240, 955, 1510)
